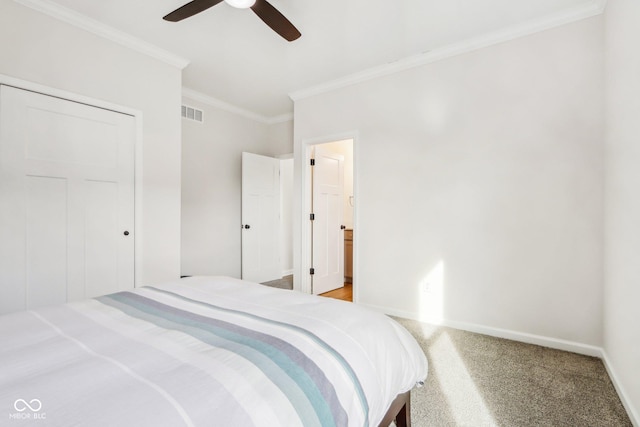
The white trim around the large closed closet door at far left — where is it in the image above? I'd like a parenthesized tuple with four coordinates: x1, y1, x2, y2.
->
(0, 74, 143, 287)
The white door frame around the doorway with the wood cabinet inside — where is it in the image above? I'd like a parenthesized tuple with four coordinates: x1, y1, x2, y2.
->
(293, 131, 360, 303)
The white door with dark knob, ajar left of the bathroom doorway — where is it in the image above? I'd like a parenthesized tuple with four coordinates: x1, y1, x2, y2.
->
(242, 153, 282, 283)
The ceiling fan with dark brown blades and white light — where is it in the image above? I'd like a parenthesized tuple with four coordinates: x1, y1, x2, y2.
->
(162, 0, 301, 41)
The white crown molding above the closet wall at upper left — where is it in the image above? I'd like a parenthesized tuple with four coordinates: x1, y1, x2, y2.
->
(13, 0, 189, 69)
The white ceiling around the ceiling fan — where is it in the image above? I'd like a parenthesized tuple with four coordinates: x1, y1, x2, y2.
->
(26, 0, 595, 117)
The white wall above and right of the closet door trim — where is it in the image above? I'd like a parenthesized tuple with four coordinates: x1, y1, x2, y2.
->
(0, 0, 181, 285)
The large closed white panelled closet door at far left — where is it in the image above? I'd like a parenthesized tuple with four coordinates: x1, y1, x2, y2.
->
(0, 86, 135, 313)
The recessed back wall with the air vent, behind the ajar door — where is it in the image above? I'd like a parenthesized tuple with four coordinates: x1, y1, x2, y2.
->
(182, 98, 291, 277)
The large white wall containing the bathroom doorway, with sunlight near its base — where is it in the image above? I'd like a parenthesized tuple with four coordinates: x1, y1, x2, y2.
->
(294, 17, 604, 346)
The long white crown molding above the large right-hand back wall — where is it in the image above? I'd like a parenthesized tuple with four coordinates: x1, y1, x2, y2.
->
(289, 0, 607, 101)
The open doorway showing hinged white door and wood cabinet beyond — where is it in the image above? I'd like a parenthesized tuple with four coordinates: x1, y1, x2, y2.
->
(307, 139, 355, 301)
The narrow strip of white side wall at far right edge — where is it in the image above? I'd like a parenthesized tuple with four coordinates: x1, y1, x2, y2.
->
(604, 0, 640, 425)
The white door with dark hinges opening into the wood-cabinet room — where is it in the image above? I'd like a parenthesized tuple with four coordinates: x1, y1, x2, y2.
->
(311, 145, 344, 294)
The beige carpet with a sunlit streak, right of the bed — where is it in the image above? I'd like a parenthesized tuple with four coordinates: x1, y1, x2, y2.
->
(396, 319, 632, 427)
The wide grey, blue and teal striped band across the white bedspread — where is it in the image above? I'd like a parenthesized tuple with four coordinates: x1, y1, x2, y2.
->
(98, 292, 358, 426)
